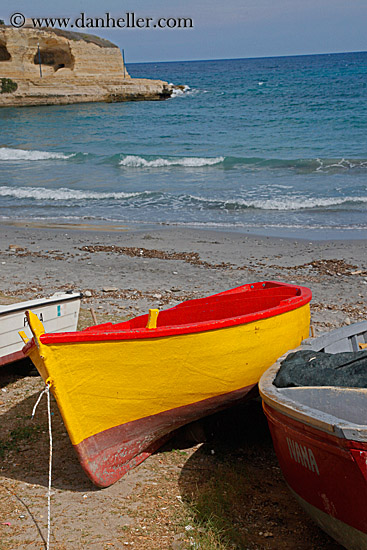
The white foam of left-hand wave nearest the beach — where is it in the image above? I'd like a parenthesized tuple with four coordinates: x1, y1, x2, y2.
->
(0, 186, 145, 201)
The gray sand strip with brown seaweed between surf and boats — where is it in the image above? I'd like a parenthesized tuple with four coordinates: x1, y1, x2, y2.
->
(0, 225, 367, 328)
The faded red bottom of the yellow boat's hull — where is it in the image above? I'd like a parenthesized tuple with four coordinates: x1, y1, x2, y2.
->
(74, 384, 257, 487)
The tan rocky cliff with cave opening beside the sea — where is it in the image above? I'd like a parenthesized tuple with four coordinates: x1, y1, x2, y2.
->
(0, 26, 172, 106)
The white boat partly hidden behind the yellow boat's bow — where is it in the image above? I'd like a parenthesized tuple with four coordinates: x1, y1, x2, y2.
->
(0, 292, 83, 367)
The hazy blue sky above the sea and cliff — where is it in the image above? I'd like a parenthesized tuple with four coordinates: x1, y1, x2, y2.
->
(0, 0, 367, 63)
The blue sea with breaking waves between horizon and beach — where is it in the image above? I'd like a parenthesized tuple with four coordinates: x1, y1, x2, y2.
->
(0, 53, 367, 238)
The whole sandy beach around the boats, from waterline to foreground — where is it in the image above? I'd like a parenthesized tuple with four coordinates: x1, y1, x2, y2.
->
(0, 223, 367, 550)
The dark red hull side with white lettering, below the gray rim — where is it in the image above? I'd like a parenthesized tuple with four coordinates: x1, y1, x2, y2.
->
(263, 403, 367, 538)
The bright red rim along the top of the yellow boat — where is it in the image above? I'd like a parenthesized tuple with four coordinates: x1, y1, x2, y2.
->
(31, 281, 312, 352)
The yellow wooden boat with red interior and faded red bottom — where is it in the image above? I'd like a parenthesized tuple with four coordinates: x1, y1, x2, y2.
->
(23, 281, 311, 487)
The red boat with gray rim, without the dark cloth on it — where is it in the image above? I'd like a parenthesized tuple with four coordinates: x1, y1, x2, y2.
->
(259, 321, 367, 550)
